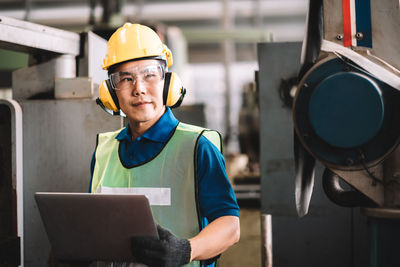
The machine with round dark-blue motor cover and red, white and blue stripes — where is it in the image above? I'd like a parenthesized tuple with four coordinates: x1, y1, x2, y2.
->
(293, 0, 400, 266)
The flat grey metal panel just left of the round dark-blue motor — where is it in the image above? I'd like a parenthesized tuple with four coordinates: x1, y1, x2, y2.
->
(258, 43, 301, 216)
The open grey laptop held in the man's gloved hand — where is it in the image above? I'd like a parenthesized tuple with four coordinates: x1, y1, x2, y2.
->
(35, 192, 158, 261)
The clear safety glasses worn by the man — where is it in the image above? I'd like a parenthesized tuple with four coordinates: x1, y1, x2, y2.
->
(109, 64, 165, 91)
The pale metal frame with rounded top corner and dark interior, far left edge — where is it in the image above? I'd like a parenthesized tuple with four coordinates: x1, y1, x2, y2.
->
(0, 99, 24, 266)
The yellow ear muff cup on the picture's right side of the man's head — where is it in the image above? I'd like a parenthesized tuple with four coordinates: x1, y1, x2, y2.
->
(163, 72, 186, 108)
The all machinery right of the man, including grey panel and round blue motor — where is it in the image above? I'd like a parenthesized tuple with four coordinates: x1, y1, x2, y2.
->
(257, 0, 400, 267)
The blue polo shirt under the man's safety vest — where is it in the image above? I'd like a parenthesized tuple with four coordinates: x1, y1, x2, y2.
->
(90, 108, 239, 227)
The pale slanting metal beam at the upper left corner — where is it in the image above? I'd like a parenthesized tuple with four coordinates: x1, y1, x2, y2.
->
(0, 16, 80, 56)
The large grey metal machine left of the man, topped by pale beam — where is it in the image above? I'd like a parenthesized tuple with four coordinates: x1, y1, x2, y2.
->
(0, 16, 122, 267)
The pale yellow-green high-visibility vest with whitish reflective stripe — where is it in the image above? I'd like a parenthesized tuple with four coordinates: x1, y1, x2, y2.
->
(91, 123, 222, 266)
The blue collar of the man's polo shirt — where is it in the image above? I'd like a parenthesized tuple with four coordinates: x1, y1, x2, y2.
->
(116, 107, 178, 143)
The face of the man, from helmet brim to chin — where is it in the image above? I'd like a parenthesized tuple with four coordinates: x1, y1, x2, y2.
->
(110, 59, 165, 125)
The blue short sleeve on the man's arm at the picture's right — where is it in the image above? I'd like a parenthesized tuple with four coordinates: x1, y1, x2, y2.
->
(196, 136, 239, 222)
